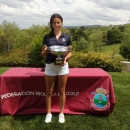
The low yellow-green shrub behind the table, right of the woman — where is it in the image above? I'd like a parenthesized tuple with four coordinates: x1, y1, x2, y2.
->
(69, 52, 122, 72)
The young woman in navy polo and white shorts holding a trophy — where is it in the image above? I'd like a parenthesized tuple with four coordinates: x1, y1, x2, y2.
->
(42, 14, 72, 123)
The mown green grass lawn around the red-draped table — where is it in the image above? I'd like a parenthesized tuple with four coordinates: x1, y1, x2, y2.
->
(0, 67, 130, 130)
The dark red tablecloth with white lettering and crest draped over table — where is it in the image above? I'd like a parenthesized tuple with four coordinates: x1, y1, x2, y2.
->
(0, 68, 115, 115)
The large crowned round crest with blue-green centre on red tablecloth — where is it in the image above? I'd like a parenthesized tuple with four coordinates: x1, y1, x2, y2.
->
(90, 88, 110, 111)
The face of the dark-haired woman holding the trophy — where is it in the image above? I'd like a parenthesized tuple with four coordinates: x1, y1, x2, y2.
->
(52, 18, 62, 31)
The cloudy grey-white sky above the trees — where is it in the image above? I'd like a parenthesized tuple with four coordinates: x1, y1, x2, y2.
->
(0, 0, 130, 29)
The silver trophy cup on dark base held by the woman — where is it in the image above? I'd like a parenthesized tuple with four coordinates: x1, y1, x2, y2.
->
(48, 46, 69, 65)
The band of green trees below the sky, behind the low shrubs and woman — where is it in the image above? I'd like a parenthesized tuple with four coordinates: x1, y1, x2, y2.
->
(0, 20, 130, 59)
